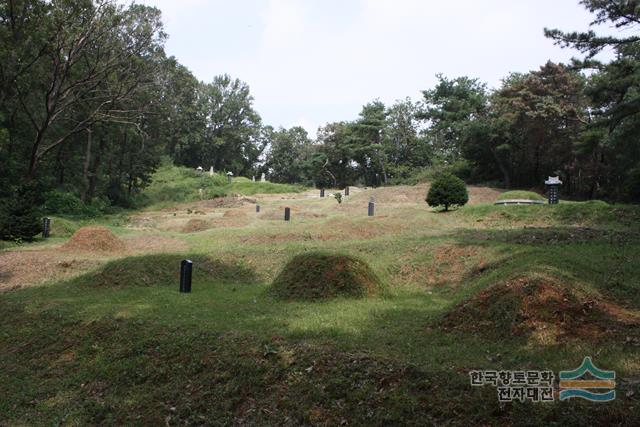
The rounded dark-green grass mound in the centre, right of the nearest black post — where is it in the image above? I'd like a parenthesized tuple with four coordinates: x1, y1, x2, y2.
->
(272, 252, 382, 300)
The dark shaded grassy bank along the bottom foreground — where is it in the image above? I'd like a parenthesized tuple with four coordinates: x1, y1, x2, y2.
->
(0, 307, 629, 425)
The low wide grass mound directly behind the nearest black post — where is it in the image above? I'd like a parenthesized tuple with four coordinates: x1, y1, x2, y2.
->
(77, 254, 257, 287)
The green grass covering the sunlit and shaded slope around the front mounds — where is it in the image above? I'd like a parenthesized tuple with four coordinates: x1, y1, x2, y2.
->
(0, 202, 640, 425)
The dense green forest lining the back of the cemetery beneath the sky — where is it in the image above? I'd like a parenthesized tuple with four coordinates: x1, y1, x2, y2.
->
(0, 0, 640, 238)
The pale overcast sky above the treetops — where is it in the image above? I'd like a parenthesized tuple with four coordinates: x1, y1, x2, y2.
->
(143, 0, 592, 136)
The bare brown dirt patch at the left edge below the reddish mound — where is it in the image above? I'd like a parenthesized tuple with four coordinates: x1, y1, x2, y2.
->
(0, 250, 99, 291)
